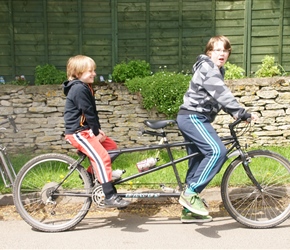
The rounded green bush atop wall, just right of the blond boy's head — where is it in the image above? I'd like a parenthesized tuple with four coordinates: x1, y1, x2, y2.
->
(112, 60, 151, 82)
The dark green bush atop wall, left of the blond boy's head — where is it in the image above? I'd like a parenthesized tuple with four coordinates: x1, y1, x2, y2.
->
(34, 64, 66, 85)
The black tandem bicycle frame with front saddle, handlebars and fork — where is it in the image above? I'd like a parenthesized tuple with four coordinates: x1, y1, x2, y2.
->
(55, 119, 262, 203)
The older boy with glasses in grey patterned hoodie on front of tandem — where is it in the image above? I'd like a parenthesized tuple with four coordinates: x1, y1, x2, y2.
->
(177, 36, 256, 223)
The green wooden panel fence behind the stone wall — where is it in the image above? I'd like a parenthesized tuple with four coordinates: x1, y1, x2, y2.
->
(0, 0, 290, 82)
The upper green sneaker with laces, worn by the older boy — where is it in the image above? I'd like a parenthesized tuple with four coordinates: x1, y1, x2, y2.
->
(179, 192, 208, 216)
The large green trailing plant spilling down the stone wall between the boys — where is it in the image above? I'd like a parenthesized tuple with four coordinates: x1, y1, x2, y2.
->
(125, 71, 191, 118)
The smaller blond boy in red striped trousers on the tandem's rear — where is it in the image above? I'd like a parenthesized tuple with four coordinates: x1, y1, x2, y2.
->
(63, 55, 129, 208)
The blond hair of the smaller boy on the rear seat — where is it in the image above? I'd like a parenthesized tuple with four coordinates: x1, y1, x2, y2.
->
(66, 55, 97, 81)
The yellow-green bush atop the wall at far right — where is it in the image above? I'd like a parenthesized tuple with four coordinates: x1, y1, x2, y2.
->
(255, 55, 285, 77)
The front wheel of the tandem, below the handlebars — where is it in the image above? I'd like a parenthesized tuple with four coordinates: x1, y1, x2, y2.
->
(221, 150, 290, 228)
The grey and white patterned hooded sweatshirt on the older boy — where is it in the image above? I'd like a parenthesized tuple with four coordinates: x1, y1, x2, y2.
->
(178, 55, 251, 122)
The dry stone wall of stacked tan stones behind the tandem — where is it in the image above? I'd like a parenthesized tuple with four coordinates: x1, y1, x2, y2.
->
(0, 77, 290, 153)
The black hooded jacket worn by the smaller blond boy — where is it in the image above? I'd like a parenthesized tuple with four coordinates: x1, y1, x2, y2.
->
(63, 80, 101, 135)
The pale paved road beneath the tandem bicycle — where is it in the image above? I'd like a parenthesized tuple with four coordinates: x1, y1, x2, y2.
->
(0, 213, 290, 249)
